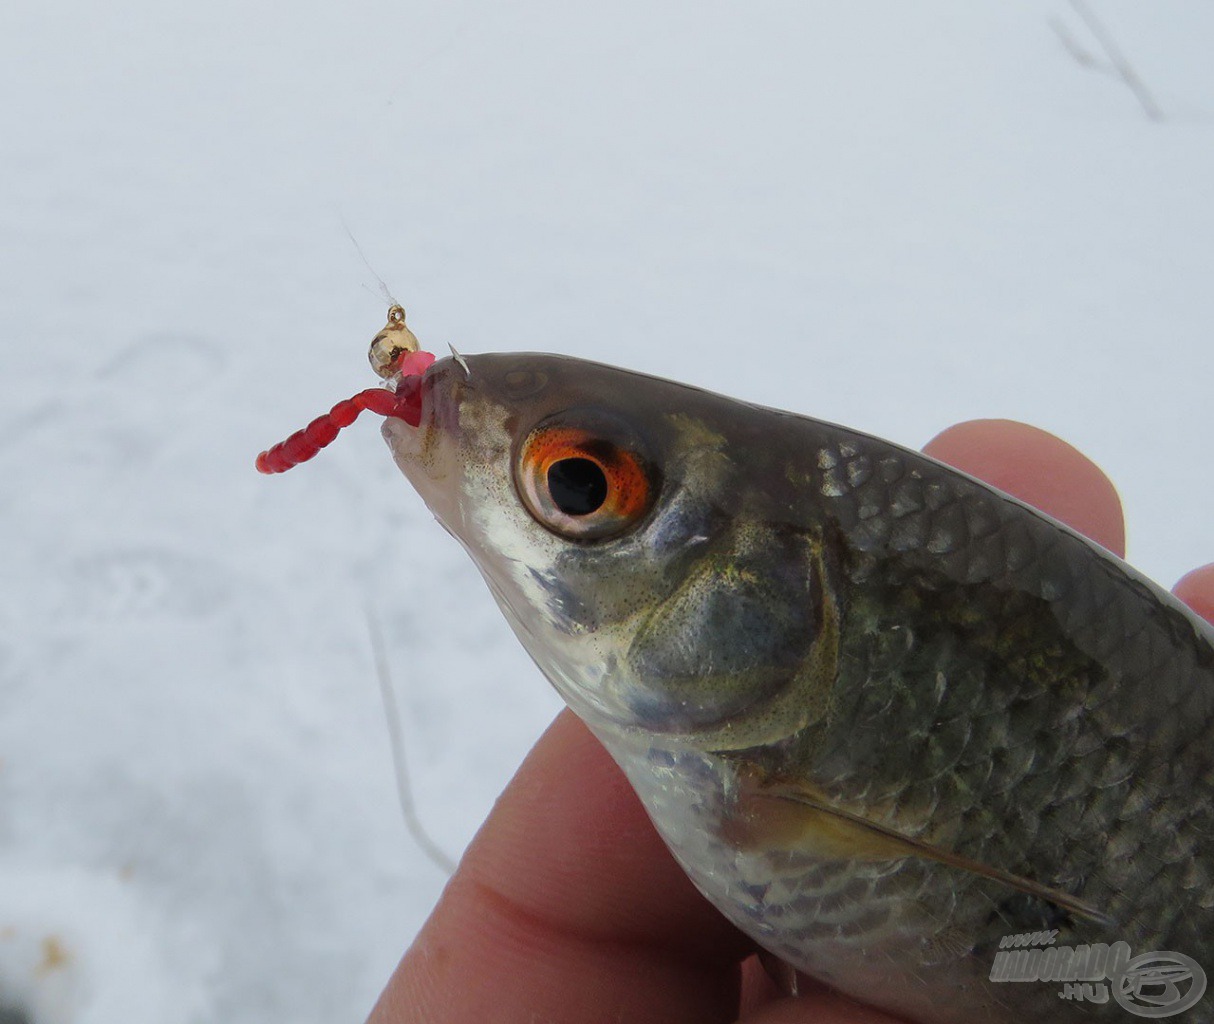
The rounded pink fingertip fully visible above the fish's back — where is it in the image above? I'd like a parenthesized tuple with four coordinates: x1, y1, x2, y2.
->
(924, 419, 1125, 556)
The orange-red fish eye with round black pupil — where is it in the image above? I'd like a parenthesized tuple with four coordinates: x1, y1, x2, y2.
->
(515, 420, 654, 541)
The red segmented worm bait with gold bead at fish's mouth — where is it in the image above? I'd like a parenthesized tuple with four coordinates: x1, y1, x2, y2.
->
(256, 306, 435, 473)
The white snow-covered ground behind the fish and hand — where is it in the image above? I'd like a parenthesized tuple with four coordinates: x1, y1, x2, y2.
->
(0, 0, 1214, 1024)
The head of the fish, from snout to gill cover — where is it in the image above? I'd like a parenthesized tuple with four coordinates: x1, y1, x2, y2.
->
(384, 353, 840, 748)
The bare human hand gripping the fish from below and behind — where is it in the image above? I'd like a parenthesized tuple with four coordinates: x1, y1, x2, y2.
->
(369, 420, 1214, 1024)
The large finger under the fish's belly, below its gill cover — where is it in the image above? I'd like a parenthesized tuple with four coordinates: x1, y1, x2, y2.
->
(371, 712, 753, 1024)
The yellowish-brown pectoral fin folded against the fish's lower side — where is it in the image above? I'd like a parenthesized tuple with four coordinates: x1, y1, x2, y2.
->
(726, 786, 1114, 927)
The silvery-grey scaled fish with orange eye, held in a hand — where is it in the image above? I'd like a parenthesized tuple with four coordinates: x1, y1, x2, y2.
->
(385, 355, 1214, 1024)
